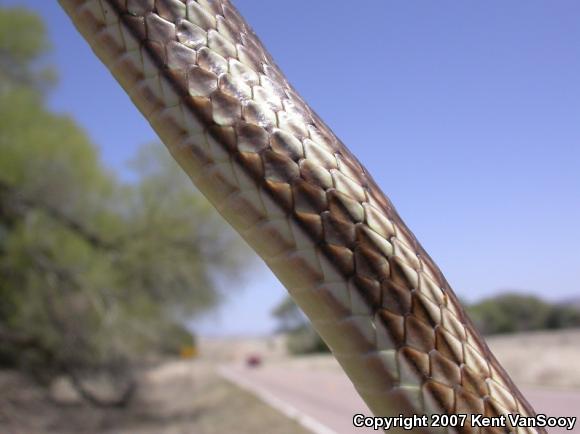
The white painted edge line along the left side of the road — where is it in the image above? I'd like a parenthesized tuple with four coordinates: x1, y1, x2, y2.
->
(218, 366, 337, 434)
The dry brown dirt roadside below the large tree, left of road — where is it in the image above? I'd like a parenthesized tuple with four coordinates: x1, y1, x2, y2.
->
(0, 361, 307, 434)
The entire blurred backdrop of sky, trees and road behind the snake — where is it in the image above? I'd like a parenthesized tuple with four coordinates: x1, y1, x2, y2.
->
(0, 0, 580, 433)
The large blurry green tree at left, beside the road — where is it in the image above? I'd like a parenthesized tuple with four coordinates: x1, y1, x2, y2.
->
(0, 8, 248, 403)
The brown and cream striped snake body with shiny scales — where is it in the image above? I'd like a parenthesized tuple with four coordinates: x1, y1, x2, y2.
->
(59, 0, 546, 433)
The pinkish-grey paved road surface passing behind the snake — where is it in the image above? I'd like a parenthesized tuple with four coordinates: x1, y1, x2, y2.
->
(225, 364, 580, 434)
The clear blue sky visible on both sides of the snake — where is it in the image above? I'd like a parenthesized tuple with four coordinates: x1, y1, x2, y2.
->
(1, 0, 580, 334)
